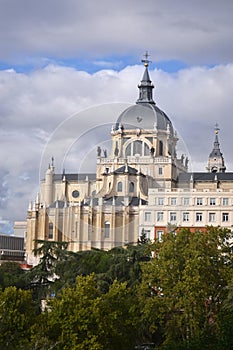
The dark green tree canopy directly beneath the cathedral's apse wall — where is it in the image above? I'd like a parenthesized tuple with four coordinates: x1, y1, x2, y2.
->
(53, 243, 151, 292)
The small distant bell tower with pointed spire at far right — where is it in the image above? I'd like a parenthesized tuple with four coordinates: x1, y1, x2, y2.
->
(207, 123, 226, 173)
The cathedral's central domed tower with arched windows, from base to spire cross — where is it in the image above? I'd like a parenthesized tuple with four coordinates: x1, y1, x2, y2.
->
(96, 52, 184, 200)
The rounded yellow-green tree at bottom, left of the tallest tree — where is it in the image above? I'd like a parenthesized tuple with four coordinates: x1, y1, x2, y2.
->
(34, 274, 139, 350)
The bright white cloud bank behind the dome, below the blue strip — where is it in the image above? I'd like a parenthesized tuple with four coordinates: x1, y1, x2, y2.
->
(0, 64, 233, 226)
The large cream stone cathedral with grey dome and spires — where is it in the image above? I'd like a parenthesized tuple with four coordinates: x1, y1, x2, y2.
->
(26, 55, 233, 263)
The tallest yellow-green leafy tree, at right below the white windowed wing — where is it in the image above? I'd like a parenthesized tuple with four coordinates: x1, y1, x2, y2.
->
(139, 227, 233, 349)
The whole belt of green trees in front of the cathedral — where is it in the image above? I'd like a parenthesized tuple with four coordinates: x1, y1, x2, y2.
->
(0, 227, 233, 350)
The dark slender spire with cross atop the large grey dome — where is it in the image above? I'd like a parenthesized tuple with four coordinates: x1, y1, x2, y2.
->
(136, 51, 155, 104)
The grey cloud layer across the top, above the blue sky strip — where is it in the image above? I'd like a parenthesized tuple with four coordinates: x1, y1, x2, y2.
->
(0, 0, 233, 64)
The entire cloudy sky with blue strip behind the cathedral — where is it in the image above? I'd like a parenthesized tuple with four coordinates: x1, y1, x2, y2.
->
(0, 0, 233, 233)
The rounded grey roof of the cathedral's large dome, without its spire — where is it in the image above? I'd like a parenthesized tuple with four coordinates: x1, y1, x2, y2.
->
(116, 103, 173, 134)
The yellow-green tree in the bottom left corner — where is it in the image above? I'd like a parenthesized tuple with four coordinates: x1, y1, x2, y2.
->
(0, 287, 36, 350)
